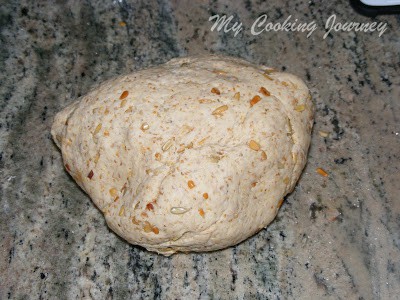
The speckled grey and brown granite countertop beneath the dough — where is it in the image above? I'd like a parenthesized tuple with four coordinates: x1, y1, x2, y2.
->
(0, 0, 400, 299)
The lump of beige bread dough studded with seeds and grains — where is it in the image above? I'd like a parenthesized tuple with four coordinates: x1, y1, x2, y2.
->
(52, 56, 313, 255)
